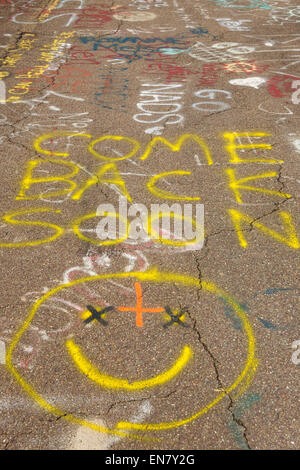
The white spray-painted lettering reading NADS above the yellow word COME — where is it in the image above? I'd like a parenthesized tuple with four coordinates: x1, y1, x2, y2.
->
(133, 83, 184, 133)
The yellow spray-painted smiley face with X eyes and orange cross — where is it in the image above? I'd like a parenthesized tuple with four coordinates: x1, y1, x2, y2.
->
(7, 269, 257, 438)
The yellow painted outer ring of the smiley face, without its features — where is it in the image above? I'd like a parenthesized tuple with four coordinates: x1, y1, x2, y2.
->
(6, 269, 258, 439)
